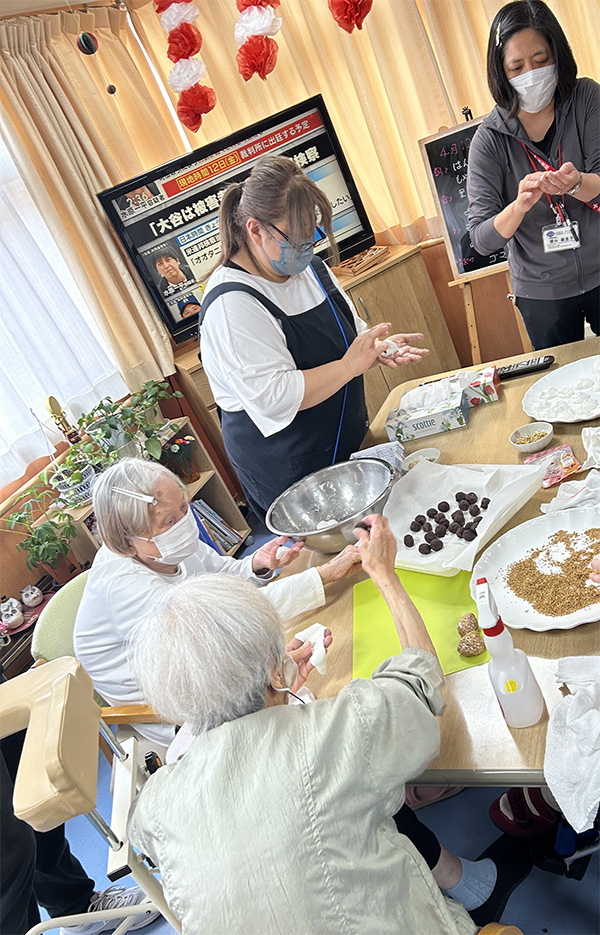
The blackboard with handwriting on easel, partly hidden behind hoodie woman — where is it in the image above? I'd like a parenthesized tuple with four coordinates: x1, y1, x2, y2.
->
(419, 117, 507, 280)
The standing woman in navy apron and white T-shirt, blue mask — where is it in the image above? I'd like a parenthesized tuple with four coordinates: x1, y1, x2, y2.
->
(200, 156, 428, 519)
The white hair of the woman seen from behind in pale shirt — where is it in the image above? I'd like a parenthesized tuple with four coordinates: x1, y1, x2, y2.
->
(129, 574, 285, 734)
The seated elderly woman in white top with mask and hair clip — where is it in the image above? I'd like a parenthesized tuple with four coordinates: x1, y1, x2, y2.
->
(74, 458, 360, 745)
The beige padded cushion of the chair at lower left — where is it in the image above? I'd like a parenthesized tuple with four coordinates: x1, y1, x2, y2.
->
(0, 656, 100, 831)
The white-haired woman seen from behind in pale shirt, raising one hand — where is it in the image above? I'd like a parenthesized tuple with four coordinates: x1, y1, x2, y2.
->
(128, 516, 531, 935)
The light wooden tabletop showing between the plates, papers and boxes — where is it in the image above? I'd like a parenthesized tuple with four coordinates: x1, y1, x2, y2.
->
(292, 338, 600, 786)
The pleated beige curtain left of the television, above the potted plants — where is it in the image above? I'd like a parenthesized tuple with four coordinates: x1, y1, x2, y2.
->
(0, 9, 183, 390)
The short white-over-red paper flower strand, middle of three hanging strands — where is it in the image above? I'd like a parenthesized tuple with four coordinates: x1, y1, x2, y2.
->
(234, 0, 281, 81)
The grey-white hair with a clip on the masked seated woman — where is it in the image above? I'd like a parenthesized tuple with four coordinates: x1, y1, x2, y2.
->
(92, 458, 187, 555)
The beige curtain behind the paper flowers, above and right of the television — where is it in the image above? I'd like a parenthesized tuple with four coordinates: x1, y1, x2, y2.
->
(127, 0, 600, 243)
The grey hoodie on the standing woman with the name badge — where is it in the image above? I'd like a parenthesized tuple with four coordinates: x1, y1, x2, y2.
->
(467, 78, 600, 299)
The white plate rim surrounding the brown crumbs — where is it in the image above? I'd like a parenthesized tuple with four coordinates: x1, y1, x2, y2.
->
(471, 509, 600, 630)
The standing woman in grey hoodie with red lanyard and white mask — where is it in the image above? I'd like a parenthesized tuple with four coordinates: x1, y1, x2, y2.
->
(467, 0, 600, 350)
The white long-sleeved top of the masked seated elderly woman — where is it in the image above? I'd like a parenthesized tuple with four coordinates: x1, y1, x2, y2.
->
(73, 542, 325, 744)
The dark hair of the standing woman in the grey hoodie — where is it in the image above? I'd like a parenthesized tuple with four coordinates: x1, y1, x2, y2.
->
(487, 0, 577, 117)
